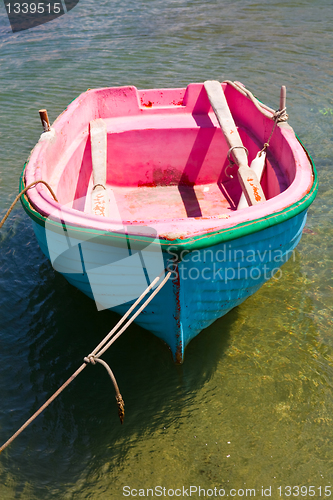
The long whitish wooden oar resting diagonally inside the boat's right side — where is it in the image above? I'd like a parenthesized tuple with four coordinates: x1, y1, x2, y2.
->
(204, 80, 266, 206)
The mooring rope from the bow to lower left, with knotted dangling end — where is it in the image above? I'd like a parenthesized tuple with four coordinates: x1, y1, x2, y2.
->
(0, 271, 171, 453)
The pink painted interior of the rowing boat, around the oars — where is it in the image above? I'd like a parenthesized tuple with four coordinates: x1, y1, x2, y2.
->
(27, 84, 310, 231)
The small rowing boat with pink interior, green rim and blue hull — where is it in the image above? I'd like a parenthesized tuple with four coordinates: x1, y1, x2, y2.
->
(21, 81, 317, 363)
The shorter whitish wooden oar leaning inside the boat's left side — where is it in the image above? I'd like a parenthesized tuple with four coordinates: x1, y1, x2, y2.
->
(90, 118, 109, 217)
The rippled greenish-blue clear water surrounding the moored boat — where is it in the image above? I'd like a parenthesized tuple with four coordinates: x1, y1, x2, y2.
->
(0, 0, 333, 500)
